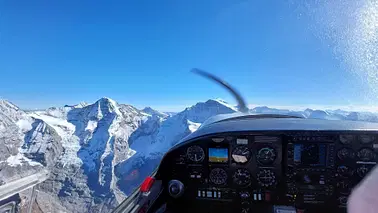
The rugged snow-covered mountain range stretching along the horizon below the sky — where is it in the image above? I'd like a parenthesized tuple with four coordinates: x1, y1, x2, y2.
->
(0, 98, 378, 212)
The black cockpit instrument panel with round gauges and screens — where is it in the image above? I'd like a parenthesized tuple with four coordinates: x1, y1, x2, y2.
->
(157, 131, 378, 212)
